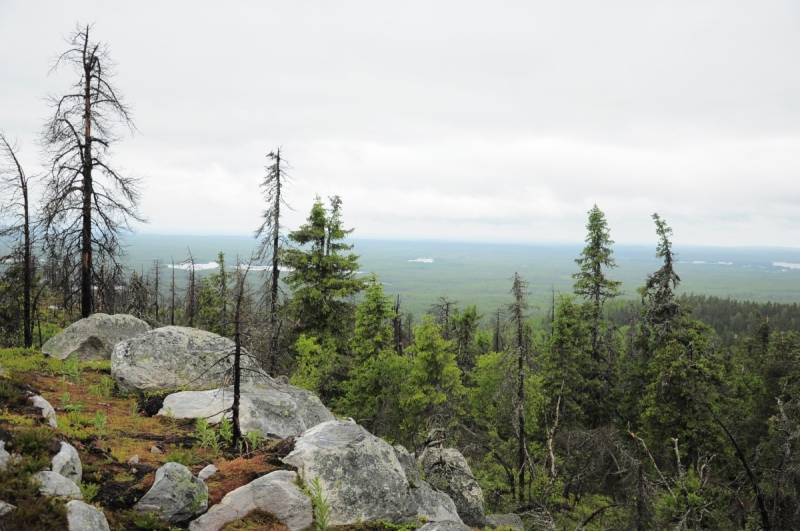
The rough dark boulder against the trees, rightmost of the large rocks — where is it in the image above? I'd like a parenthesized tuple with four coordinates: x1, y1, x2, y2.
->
(419, 446, 486, 528)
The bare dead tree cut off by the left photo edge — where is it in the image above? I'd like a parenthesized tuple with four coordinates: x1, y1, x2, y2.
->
(0, 131, 34, 348)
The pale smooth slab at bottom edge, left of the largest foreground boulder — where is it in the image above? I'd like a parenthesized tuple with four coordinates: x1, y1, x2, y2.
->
(189, 470, 312, 531)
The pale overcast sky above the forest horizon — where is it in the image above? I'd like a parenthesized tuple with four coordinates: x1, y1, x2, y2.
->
(0, 0, 800, 247)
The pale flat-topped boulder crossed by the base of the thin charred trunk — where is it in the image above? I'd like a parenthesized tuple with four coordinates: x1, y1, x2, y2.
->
(158, 382, 334, 439)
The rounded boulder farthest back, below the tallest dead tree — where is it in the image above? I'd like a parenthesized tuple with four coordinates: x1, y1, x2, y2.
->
(42, 313, 150, 361)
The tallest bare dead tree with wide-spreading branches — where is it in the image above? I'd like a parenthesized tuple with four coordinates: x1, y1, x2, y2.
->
(41, 25, 145, 317)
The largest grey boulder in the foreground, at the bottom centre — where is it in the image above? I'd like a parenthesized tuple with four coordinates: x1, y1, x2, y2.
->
(283, 420, 458, 525)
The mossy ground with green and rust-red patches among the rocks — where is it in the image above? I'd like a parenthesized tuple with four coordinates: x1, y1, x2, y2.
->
(0, 349, 285, 531)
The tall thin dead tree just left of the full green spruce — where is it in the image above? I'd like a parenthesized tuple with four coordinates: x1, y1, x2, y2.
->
(255, 148, 291, 374)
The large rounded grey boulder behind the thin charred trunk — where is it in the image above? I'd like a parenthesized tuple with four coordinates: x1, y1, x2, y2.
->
(111, 326, 268, 393)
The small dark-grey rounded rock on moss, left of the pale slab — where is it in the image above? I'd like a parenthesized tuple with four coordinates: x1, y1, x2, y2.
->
(133, 463, 208, 524)
